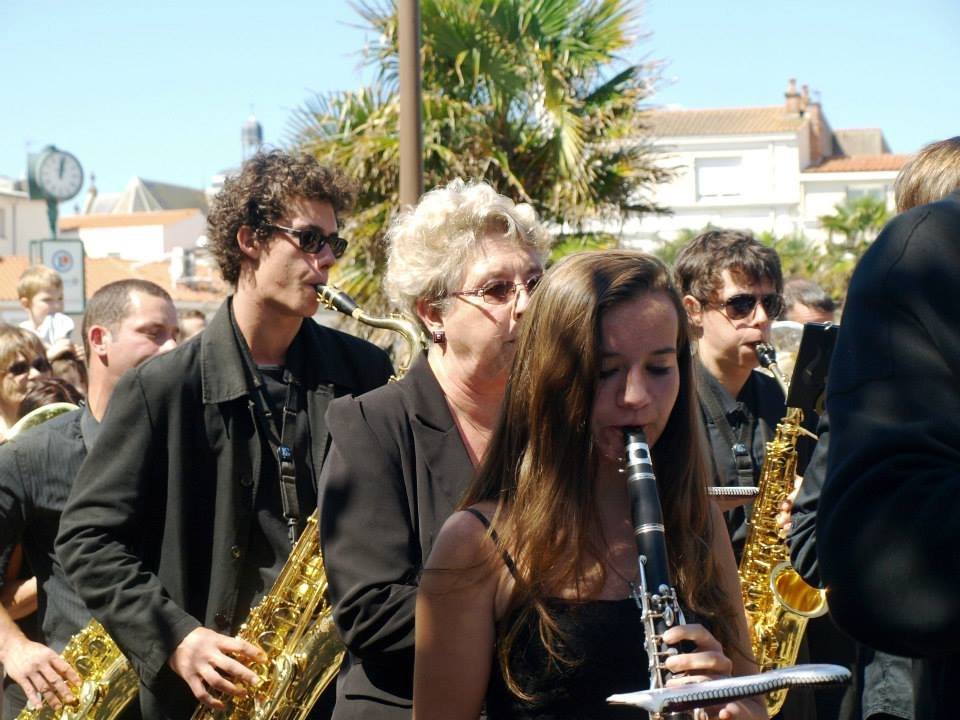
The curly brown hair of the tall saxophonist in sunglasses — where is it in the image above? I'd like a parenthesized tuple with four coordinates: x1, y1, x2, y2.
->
(207, 150, 356, 285)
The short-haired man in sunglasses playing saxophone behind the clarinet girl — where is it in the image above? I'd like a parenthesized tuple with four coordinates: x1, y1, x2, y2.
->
(674, 230, 849, 720)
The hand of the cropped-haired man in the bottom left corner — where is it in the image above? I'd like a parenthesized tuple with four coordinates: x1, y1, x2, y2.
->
(0, 635, 80, 710)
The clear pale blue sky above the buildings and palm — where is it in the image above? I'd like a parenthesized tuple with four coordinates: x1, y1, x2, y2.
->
(0, 0, 960, 210)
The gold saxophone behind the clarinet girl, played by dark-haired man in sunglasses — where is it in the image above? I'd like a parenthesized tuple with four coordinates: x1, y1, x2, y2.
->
(740, 346, 827, 717)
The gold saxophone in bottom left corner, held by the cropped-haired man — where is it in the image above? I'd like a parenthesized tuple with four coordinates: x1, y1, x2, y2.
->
(17, 620, 140, 720)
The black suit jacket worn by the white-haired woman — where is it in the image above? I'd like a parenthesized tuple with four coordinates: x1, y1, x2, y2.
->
(320, 355, 474, 720)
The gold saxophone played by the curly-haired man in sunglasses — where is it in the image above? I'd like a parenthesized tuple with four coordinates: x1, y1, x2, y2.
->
(193, 285, 424, 720)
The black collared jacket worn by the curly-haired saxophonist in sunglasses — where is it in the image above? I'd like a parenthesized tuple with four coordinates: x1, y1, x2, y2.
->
(57, 301, 391, 718)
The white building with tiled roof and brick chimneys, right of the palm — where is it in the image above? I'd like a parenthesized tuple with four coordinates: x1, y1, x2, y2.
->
(622, 80, 908, 247)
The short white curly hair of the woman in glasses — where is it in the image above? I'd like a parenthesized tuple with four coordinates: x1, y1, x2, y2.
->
(384, 178, 550, 334)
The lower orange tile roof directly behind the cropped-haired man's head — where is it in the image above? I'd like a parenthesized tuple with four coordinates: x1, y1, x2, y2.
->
(0, 255, 227, 303)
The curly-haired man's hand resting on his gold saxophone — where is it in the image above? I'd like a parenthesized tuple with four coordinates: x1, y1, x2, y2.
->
(167, 627, 267, 710)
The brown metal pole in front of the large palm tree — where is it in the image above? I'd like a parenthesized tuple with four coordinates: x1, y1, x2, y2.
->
(397, 0, 423, 207)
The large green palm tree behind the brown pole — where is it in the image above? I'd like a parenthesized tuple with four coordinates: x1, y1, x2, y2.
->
(290, 0, 666, 311)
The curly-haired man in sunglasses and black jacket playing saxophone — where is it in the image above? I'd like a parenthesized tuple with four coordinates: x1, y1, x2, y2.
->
(57, 151, 392, 718)
